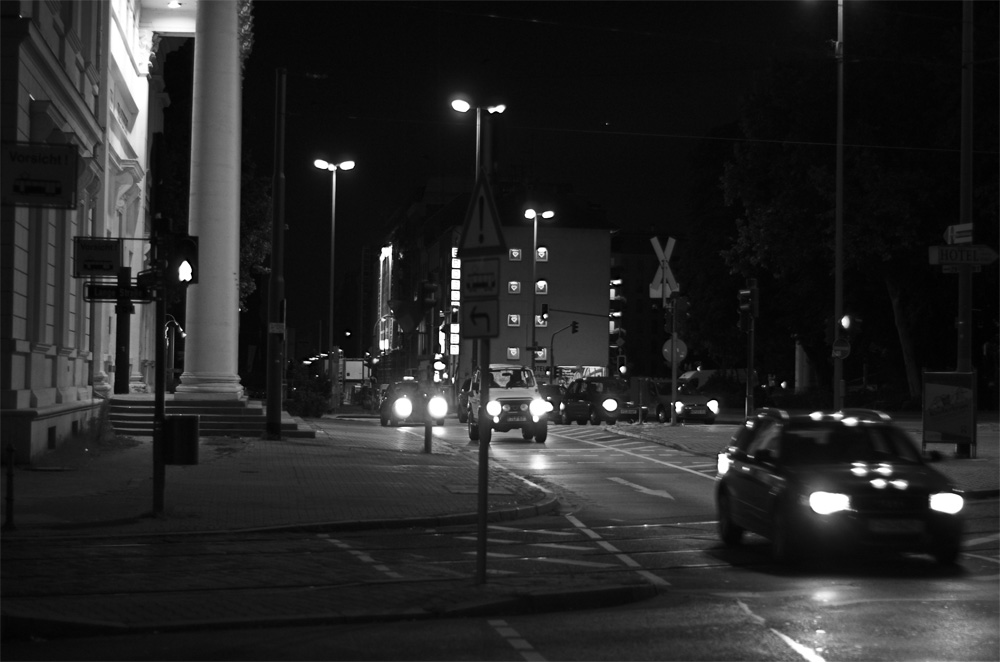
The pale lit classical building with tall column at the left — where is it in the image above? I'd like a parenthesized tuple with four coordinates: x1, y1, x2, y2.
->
(0, 0, 251, 463)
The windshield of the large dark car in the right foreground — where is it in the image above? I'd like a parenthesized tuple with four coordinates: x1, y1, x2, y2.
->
(784, 426, 921, 465)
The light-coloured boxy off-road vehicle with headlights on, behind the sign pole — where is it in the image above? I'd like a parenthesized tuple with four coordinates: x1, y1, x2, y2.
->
(468, 363, 551, 443)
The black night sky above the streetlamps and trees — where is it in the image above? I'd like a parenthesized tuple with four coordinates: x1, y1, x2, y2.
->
(244, 0, 976, 352)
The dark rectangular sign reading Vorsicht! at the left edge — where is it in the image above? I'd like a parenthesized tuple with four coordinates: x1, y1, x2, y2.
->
(0, 142, 79, 209)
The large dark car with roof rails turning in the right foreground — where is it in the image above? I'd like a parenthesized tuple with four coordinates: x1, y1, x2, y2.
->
(716, 410, 964, 564)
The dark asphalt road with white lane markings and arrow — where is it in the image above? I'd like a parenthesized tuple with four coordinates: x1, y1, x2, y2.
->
(2, 420, 1000, 661)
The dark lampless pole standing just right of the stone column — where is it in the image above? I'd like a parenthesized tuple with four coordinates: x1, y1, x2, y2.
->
(267, 68, 285, 439)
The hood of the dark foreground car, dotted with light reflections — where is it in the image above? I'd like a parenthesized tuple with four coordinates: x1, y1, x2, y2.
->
(789, 462, 952, 494)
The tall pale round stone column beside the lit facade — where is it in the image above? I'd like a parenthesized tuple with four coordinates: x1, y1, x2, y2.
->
(175, 0, 243, 400)
